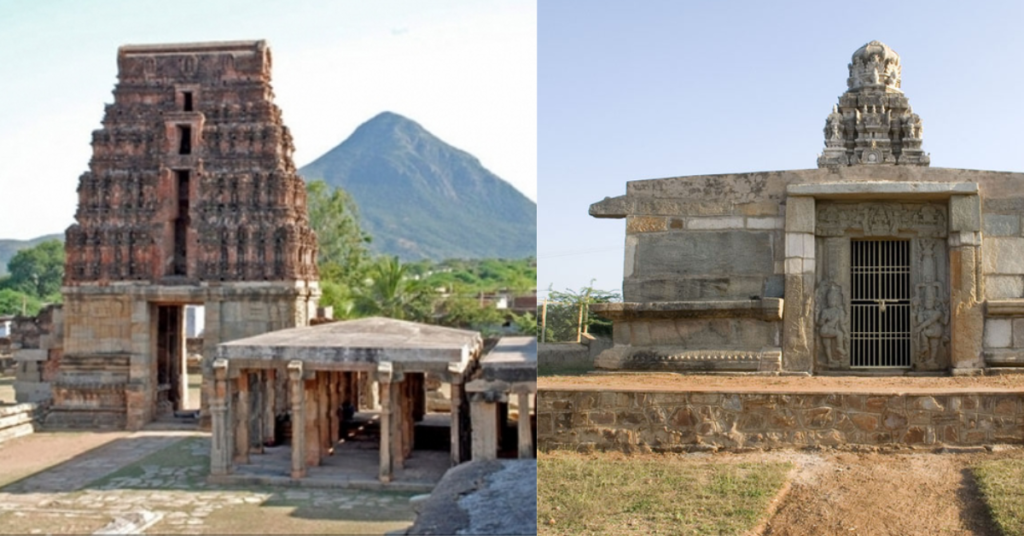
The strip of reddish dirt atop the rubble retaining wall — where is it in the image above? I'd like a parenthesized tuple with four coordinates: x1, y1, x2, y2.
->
(537, 372, 1024, 396)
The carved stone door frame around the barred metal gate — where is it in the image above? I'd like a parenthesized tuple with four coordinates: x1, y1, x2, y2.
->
(782, 180, 984, 373)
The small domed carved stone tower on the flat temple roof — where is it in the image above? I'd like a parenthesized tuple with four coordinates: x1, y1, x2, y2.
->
(818, 41, 931, 167)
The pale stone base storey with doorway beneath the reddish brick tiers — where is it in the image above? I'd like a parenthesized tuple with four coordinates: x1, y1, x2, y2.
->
(46, 282, 318, 429)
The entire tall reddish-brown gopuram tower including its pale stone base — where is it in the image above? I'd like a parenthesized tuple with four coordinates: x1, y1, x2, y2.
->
(54, 41, 319, 429)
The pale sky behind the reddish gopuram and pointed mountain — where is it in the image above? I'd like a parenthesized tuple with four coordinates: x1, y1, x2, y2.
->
(0, 0, 537, 239)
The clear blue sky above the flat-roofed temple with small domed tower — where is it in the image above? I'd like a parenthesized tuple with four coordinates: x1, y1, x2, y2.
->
(538, 0, 1024, 294)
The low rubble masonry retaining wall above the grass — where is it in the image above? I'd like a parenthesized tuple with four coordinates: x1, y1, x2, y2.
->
(538, 389, 1024, 452)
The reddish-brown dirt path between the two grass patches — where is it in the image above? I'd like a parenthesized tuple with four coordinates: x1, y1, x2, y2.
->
(762, 449, 1007, 536)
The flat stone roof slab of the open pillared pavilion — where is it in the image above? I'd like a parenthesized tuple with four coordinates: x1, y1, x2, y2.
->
(217, 317, 483, 364)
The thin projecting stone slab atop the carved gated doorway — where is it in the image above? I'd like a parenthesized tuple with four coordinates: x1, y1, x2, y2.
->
(785, 180, 978, 201)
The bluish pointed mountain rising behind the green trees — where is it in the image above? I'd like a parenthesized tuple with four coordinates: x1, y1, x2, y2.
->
(299, 112, 537, 260)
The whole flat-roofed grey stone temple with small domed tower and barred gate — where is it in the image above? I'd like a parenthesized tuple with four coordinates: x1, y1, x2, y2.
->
(590, 41, 1024, 374)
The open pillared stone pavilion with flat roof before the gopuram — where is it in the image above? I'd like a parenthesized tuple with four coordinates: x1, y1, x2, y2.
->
(210, 318, 483, 491)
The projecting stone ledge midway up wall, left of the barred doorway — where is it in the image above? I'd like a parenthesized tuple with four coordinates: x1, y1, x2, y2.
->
(590, 298, 783, 321)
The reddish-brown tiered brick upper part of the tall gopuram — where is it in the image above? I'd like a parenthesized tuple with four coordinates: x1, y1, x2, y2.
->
(65, 41, 317, 286)
